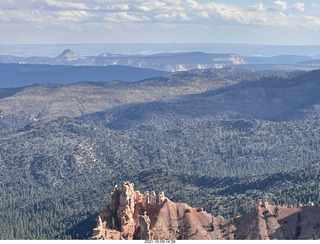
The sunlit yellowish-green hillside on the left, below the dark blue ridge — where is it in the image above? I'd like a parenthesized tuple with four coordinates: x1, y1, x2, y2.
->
(0, 68, 245, 132)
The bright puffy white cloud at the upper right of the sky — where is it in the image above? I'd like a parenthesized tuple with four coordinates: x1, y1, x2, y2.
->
(188, 0, 319, 28)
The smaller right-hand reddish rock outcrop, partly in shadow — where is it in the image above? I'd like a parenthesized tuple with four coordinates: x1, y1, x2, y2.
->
(229, 200, 320, 240)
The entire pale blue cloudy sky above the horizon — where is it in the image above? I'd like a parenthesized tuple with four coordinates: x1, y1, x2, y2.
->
(0, 0, 320, 45)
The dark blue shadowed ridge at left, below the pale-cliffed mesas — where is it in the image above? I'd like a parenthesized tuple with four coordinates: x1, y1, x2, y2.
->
(0, 63, 168, 88)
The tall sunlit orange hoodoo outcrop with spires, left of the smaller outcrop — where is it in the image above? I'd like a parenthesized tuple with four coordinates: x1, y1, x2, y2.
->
(92, 182, 233, 240)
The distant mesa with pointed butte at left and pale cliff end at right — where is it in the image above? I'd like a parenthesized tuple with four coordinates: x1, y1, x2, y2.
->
(0, 49, 245, 72)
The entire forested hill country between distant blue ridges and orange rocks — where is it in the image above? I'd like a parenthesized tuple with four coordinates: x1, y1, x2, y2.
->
(0, 68, 320, 239)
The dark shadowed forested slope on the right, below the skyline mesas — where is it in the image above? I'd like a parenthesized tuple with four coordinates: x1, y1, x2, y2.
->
(83, 68, 320, 130)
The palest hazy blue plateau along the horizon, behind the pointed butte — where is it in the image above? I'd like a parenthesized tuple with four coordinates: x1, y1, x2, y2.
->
(0, 43, 320, 59)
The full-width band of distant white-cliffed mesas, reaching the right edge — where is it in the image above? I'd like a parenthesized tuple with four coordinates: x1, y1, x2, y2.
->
(0, 49, 320, 76)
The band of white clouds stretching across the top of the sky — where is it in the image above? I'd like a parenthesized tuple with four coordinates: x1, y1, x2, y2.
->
(0, 0, 320, 28)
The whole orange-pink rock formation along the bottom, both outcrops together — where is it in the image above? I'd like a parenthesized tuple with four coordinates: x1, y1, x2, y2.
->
(92, 182, 320, 240)
